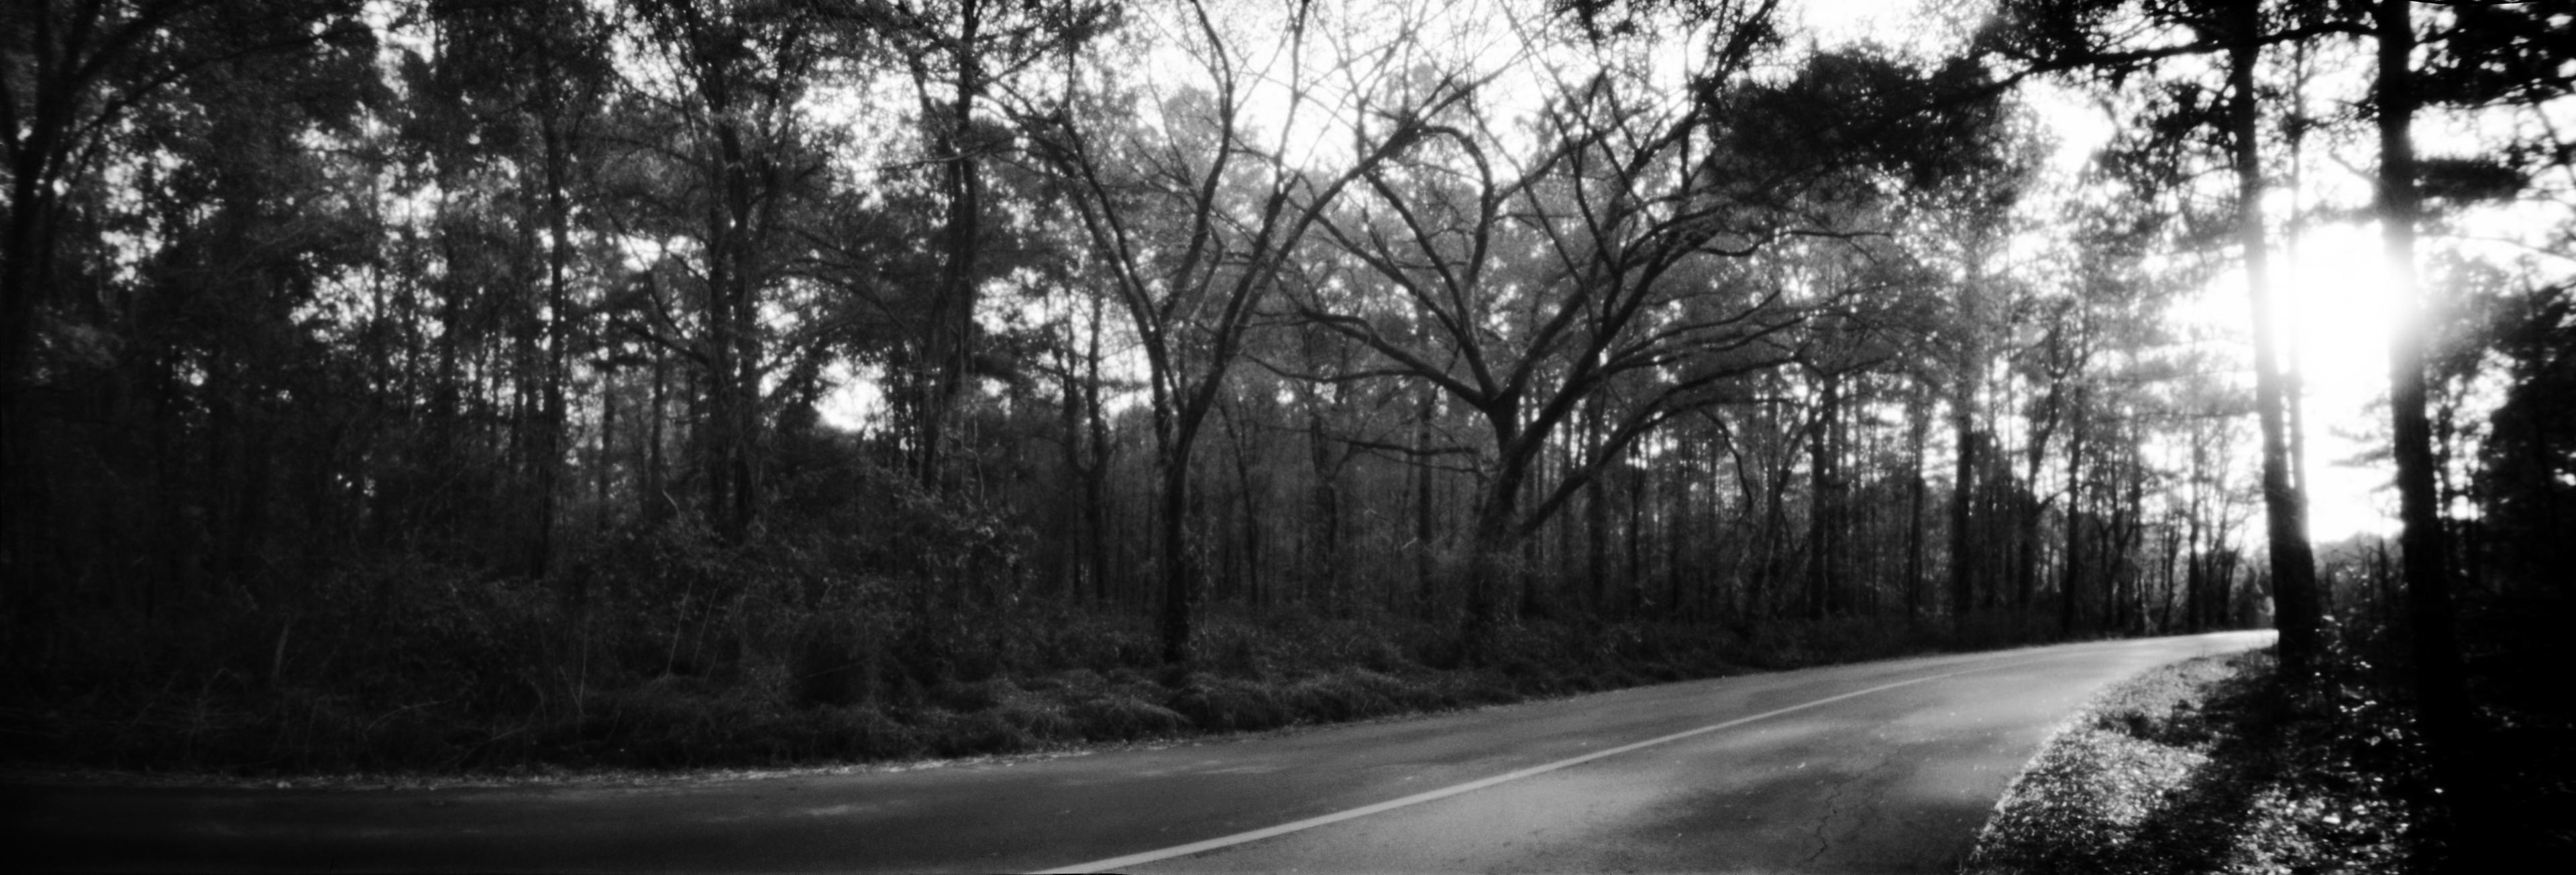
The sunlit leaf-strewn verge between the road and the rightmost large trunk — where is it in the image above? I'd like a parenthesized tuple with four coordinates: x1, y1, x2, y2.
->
(1963, 648, 2414, 875)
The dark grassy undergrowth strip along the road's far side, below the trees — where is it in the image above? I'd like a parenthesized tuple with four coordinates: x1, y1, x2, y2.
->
(0, 538, 2053, 780)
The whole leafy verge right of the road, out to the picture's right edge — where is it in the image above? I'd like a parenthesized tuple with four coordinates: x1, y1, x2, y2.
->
(1960, 591, 2576, 875)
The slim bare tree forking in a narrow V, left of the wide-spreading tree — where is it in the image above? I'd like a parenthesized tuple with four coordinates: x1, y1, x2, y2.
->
(1020, 0, 1473, 677)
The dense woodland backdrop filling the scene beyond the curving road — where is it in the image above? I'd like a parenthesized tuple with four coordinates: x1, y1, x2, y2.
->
(0, 0, 2576, 833)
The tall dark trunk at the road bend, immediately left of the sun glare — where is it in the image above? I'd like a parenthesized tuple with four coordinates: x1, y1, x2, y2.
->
(2229, 0, 2321, 682)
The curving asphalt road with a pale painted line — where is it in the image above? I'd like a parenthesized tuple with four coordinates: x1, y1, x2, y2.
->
(15, 633, 2269, 872)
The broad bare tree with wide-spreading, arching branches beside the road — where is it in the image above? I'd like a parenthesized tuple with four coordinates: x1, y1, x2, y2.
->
(1298, 3, 1994, 641)
